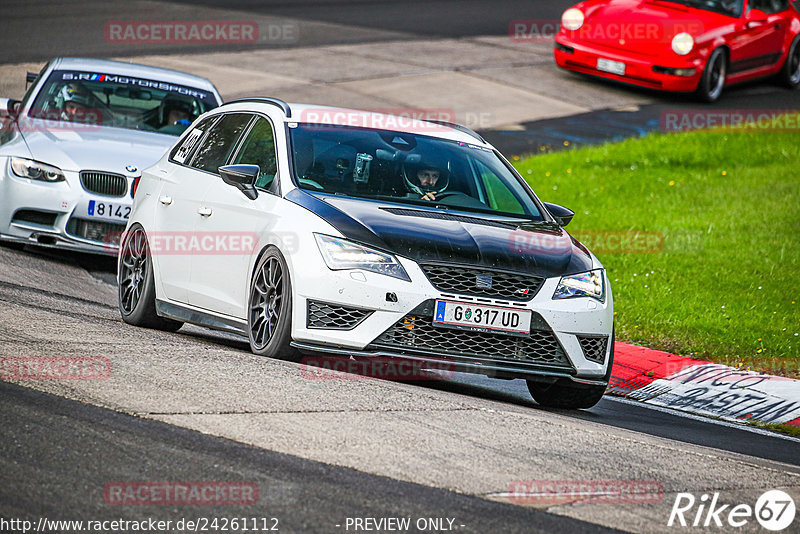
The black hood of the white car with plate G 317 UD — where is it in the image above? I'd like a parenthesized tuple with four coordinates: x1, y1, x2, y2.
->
(286, 189, 592, 277)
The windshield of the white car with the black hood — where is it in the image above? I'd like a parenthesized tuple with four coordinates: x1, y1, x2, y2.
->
(289, 124, 543, 221)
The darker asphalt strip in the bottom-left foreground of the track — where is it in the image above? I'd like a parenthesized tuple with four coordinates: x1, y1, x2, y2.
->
(0, 382, 615, 533)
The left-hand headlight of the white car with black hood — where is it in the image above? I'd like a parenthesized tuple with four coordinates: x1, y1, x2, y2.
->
(314, 234, 411, 282)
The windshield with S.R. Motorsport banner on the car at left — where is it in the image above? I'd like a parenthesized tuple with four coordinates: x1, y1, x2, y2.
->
(28, 70, 217, 135)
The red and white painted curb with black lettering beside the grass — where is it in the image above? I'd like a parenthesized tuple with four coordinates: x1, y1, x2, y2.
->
(607, 342, 800, 426)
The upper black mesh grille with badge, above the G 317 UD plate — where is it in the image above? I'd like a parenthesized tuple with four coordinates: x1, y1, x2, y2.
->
(420, 264, 544, 301)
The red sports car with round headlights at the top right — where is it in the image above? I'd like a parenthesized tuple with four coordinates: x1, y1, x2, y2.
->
(554, 0, 800, 102)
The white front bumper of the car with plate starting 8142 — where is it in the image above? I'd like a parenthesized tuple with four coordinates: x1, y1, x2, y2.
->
(0, 158, 132, 256)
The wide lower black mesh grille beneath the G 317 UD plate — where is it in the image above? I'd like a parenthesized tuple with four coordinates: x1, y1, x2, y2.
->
(371, 313, 571, 368)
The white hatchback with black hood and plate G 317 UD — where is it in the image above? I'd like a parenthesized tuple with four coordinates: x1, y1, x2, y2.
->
(118, 98, 614, 408)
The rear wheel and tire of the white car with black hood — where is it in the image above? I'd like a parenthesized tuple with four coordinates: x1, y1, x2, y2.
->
(117, 224, 183, 332)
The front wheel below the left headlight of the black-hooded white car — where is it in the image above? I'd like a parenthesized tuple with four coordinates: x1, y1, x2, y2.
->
(247, 247, 301, 362)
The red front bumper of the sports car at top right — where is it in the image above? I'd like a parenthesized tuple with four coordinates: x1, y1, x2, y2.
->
(553, 34, 704, 93)
